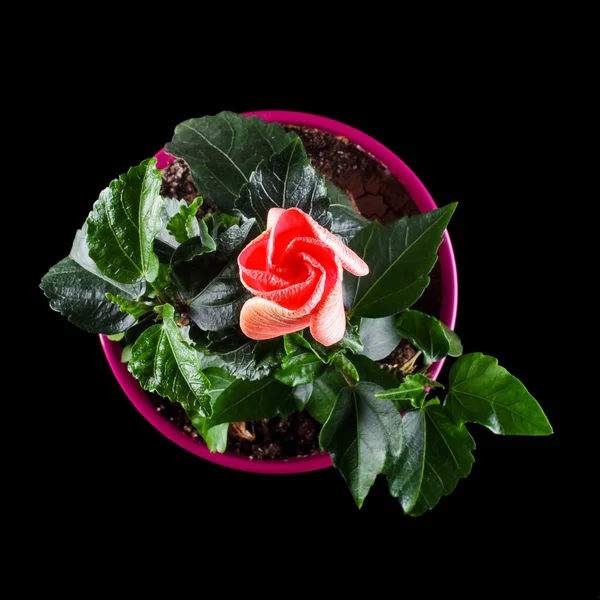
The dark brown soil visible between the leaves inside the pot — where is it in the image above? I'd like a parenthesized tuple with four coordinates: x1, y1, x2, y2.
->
(150, 128, 441, 460)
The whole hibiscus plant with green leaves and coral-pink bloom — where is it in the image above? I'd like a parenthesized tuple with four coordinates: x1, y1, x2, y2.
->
(41, 112, 552, 515)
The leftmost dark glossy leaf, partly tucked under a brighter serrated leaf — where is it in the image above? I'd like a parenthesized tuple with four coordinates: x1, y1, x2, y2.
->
(40, 225, 146, 335)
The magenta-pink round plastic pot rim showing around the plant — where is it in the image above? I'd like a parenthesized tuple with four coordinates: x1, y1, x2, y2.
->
(100, 110, 458, 474)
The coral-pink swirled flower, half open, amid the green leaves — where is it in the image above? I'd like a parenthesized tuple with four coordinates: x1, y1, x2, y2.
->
(238, 208, 369, 346)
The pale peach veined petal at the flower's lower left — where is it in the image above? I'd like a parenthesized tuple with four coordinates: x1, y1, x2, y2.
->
(240, 298, 312, 340)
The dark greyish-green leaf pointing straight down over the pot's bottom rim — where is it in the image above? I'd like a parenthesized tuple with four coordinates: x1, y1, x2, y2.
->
(320, 382, 402, 508)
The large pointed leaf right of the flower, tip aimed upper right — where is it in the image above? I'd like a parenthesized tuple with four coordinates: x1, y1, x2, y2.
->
(344, 204, 456, 318)
